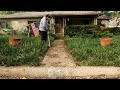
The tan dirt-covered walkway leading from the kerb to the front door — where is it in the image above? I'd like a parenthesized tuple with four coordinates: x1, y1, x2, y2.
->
(42, 39, 76, 67)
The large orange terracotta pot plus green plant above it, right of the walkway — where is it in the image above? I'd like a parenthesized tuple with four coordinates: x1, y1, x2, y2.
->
(100, 30, 113, 46)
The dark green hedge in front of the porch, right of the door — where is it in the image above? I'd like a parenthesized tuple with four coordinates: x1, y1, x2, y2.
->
(65, 25, 120, 38)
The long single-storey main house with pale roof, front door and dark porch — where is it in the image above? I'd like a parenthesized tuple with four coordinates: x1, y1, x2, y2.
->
(0, 11, 101, 36)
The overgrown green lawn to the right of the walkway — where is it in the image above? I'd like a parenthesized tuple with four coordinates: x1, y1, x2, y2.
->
(65, 36, 120, 66)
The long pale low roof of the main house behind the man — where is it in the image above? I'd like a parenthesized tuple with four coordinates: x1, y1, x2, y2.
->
(0, 11, 101, 19)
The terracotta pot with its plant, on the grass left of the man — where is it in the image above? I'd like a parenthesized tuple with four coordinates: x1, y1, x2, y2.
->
(9, 30, 20, 47)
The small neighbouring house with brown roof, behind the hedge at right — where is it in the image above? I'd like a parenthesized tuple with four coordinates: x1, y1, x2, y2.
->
(97, 15, 111, 27)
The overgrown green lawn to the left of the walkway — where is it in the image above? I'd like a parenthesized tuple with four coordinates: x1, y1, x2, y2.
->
(0, 36, 53, 66)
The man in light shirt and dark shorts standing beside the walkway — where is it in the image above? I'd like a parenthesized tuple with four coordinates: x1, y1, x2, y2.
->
(39, 14, 50, 44)
